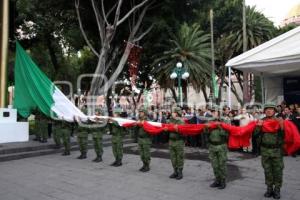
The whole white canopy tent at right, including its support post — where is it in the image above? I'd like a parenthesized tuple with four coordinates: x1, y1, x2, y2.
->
(226, 26, 300, 107)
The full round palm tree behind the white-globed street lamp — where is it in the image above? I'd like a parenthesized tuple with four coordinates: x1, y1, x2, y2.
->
(153, 23, 211, 103)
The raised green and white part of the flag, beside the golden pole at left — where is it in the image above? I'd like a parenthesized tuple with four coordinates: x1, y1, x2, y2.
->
(14, 42, 86, 121)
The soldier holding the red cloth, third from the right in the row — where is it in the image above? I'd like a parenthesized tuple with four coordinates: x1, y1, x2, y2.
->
(168, 107, 184, 180)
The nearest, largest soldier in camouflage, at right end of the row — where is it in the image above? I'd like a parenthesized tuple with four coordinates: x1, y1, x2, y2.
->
(253, 103, 284, 199)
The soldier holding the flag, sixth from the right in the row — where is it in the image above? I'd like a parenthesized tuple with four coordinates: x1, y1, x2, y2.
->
(91, 110, 106, 162)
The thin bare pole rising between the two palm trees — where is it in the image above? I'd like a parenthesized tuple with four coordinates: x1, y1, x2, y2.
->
(209, 9, 216, 102)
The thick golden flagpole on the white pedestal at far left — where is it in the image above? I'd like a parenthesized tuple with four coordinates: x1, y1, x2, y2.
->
(0, 0, 9, 108)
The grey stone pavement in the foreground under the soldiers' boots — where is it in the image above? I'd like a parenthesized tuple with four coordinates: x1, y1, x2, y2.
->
(0, 144, 300, 200)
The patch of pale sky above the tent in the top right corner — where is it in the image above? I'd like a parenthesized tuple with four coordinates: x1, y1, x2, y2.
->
(246, 0, 300, 26)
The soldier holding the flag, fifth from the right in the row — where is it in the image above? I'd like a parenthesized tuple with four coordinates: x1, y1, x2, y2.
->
(108, 108, 124, 167)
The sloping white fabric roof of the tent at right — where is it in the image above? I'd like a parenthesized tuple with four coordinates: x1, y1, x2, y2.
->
(226, 26, 300, 76)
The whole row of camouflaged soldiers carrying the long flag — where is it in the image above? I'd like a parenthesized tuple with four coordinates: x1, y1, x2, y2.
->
(34, 104, 284, 199)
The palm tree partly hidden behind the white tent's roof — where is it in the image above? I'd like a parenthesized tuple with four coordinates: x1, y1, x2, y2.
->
(217, 5, 276, 103)
